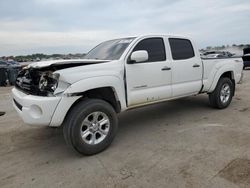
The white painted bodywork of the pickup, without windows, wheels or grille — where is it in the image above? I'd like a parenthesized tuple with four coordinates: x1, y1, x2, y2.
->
(12, 35, 243, 126)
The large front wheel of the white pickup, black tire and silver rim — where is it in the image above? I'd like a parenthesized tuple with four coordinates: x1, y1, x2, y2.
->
(63, 99, 118, 155)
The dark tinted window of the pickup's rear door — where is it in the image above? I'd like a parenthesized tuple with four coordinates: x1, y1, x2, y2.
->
(168, 38, 195, 60)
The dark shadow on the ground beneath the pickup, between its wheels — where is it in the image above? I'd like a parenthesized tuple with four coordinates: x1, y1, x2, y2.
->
(117, 95, 211, 140)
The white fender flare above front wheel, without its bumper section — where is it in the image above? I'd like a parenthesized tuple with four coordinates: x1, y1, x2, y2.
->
(64, 76, 126, 110)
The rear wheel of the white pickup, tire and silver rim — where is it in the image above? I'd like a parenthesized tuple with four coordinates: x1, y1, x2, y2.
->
(209, 77, 235, 109)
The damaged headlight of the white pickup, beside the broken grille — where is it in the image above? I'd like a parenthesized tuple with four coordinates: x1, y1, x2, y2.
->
(38, 72, 60, 93)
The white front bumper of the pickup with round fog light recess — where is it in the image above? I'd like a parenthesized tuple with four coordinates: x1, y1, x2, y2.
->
(12, 88, 62, 126)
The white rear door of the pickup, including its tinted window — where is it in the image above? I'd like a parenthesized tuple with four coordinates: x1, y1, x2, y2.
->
(169, 38, 202, 97)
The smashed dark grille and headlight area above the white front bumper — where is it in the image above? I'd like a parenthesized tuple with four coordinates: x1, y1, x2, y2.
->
(15, 68, 60, 96)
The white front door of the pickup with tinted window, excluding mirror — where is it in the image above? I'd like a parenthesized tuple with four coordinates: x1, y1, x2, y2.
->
(126, 37, 172, 106)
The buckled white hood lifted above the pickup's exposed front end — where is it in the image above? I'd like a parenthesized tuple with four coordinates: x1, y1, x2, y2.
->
(28, 59, 109, 70)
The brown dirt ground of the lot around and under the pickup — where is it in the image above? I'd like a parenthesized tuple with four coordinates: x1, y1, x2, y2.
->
(0, 70, 250, 188)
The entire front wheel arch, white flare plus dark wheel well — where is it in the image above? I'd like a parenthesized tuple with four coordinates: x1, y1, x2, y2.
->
(50, 76, 126, 127)
